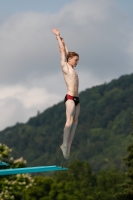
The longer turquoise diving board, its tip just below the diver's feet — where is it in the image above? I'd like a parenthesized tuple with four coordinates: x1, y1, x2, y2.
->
(0, 165, 68, 176)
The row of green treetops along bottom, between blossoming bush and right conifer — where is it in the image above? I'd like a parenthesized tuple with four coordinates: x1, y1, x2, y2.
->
(23, 161, 124, 200)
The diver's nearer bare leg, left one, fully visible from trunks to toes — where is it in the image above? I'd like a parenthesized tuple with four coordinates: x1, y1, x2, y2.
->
(60, 99, 75, 159)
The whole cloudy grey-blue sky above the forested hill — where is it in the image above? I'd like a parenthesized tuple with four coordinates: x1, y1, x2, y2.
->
(0, 0, 133, 130)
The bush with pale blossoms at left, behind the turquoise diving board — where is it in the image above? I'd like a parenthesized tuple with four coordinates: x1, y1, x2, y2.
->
(0, 144, 34, 200)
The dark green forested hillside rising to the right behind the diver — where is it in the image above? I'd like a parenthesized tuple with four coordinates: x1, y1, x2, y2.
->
(0, 74, 133, 171)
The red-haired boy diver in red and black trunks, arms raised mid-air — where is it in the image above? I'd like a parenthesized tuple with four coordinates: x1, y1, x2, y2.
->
(52, 29, 80, 159)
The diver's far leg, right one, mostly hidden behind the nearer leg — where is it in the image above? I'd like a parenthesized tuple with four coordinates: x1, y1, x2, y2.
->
(68, 103, 80, 157)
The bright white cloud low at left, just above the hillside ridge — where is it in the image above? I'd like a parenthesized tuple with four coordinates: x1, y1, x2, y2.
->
(0, 85, 62, 130)
